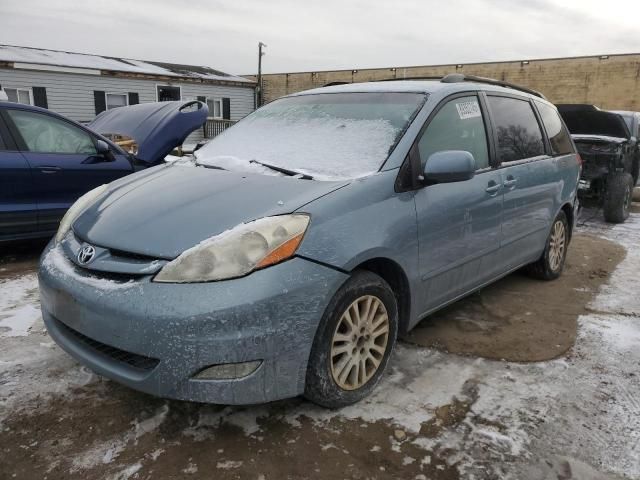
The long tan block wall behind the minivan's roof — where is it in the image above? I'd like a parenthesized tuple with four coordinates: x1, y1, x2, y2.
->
(258, 54, 640, 111)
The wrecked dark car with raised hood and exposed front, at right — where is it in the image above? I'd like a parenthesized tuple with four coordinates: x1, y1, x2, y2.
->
(558, 104, 640, 223)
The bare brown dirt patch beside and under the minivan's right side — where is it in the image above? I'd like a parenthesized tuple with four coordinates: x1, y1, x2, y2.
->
(405, 234, 626, 362)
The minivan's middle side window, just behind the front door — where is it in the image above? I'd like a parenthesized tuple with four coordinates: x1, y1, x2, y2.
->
(487, 96, 544, 162)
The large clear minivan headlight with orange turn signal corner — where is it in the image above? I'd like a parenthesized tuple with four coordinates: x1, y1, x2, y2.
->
(154, 214, 309, 283)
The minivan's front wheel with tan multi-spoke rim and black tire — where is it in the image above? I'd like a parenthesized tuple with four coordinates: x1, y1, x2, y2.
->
(304, 270, 398, 408)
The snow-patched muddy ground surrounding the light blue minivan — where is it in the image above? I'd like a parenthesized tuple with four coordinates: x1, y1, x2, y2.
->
(0, 213, 640, 480)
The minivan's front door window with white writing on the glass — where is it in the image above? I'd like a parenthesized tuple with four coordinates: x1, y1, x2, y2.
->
(418, 95, 489, 169)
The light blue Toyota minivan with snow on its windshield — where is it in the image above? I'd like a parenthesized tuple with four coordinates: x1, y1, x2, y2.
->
(39, 75, 581, 407)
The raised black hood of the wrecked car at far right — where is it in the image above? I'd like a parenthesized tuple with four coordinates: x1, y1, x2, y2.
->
(557, 105, 631, 139)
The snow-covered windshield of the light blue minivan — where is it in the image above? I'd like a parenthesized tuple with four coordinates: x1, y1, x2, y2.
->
(195, 93, 426, 180)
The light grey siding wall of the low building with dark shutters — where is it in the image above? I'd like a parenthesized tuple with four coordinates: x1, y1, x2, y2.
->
(0, 68, 254, 143)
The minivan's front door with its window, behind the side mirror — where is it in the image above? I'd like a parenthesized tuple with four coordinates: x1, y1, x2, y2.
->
(415, 95, 502, 313)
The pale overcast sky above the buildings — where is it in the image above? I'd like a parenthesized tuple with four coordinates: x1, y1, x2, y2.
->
(0, 0, 640, 74)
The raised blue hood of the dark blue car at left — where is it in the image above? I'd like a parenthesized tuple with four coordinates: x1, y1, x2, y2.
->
(87, 101, 209, 164)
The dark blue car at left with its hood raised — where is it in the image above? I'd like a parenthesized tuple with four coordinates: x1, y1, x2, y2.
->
(0, 102, 207, 242)
